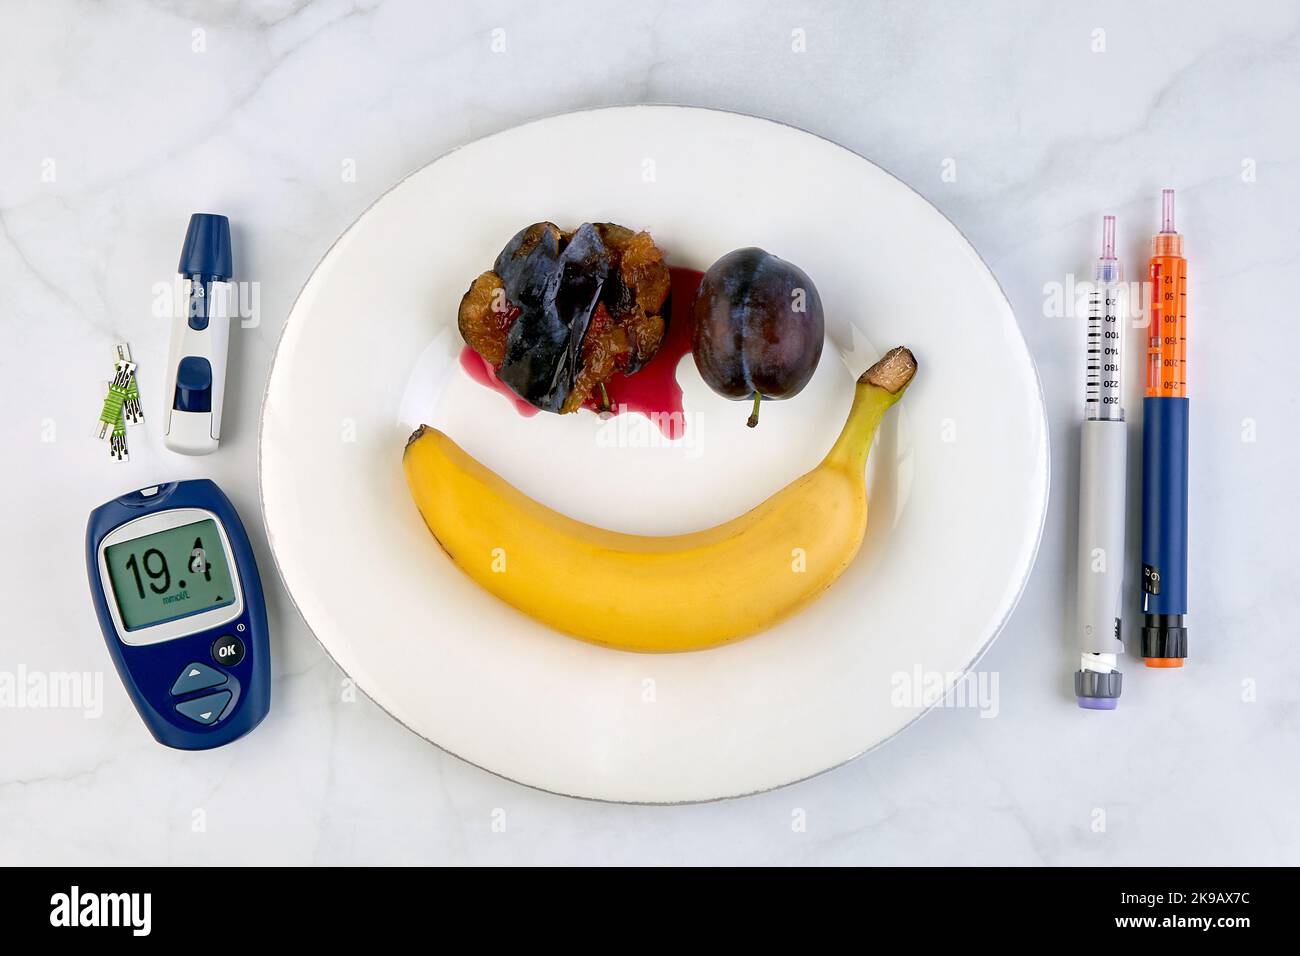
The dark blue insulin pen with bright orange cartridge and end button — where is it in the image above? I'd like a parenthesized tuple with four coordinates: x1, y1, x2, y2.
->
(1141, 189, 1188, 667)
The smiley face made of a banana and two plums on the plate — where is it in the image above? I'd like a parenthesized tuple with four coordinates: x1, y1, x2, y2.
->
(402, 222, 917, 652)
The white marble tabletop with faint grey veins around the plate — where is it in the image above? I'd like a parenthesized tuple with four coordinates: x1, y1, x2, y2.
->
(0, 0, 1300, 865)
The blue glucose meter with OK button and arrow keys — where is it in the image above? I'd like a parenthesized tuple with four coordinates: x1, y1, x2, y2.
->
(86, 479, 270, 750)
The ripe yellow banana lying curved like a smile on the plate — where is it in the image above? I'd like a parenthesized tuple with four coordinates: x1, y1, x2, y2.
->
(402, 349, 917, 652)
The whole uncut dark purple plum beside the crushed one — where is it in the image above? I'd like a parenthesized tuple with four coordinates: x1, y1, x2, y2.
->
(692, 247, 826, 399)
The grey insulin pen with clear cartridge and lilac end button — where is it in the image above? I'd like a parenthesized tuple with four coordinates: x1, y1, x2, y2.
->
(1074, 216, 1127, 710)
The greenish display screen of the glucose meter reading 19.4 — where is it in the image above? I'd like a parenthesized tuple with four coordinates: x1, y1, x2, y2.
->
(104, 518, 235, 631)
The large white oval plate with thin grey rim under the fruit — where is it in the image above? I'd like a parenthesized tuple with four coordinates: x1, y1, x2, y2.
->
(259, 107, 1048, 803)
